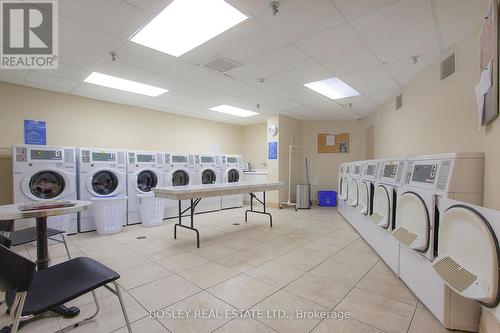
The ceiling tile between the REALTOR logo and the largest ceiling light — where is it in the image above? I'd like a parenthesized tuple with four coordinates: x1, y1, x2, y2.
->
(59, 17, 123, 56)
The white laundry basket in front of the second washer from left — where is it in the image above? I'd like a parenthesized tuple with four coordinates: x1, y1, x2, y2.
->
(90, 196, 127, 235)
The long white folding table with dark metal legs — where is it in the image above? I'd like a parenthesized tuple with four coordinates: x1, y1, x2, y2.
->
(153, 182, 285, 247)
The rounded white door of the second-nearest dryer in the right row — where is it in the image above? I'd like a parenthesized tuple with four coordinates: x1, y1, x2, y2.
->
(392, 192, 431, 252)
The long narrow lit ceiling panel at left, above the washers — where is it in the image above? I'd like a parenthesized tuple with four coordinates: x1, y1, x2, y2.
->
(84, 72, 168, 97)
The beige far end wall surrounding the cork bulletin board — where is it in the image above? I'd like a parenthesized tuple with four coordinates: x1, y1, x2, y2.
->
(302, 120, 366, 198)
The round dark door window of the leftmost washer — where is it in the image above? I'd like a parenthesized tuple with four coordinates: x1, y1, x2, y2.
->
(29, 171, 66, 199)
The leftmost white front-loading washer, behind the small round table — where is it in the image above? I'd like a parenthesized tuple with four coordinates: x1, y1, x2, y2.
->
(13, 145, 77, 234)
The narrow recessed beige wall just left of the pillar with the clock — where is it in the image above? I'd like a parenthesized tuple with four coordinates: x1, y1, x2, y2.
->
(243, 122, 267, 170)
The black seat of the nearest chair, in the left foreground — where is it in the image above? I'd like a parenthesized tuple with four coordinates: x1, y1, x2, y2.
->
(23, 257, 120, 316)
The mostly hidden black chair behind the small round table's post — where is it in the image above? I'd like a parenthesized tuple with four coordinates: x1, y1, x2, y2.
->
(0, 220, 71, 259)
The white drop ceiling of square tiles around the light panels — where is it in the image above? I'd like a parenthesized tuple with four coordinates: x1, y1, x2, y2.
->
(0, 0, 487, 125)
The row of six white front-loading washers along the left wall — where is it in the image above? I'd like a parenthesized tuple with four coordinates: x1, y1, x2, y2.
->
(13, 145, 243, 234)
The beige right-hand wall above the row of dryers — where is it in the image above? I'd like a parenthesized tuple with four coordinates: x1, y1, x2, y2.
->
(364, 28, 500, 210)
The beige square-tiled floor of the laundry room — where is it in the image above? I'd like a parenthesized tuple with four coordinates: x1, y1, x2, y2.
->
(0, 208, 458, 333)
